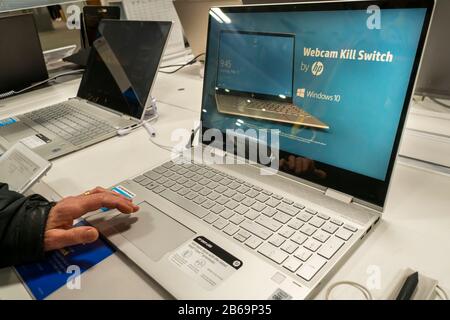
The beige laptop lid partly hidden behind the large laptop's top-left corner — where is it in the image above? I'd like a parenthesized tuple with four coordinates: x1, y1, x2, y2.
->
(173, 0, 242, 61)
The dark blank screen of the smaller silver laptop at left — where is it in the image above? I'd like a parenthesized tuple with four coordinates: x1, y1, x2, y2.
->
(78, 20, 172, 119)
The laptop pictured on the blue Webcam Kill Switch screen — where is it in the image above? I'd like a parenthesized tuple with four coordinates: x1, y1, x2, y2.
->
(216, 30, 329, 129)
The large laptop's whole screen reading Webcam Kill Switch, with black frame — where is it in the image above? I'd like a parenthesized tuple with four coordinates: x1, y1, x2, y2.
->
(202, 1, 433, 206)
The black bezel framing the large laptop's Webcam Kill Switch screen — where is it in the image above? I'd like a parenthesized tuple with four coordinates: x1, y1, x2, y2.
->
(201, 0, 434, 211)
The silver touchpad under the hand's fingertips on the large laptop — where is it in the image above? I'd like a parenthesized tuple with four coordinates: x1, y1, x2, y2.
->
(121, 201, 195, 261)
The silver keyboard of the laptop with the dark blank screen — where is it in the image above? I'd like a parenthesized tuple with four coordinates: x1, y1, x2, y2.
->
(23, 103, 116, 146)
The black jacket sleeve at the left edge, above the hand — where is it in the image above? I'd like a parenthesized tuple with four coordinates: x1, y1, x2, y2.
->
(0, 183, 53, 268)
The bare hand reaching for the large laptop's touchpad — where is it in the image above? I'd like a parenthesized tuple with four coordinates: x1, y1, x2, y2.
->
(44, 187, 139, 251)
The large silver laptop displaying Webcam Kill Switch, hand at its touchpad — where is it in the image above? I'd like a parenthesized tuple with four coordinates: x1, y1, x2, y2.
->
(84, 1, 434, 299)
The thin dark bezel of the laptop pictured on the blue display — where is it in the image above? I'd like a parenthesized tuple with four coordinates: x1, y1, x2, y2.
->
(216, 30, 295, 103)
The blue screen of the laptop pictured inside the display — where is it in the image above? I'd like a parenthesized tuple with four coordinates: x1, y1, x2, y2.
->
(217, 32, 294, 97)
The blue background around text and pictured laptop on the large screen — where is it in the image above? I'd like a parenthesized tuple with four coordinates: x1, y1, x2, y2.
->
(202, 8, 426, 180)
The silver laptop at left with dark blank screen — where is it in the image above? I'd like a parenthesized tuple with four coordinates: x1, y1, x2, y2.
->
(0, 20, 172, 160)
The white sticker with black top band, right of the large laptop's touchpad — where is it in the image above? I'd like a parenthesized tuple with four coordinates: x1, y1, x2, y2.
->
(169, 236, 242, 290)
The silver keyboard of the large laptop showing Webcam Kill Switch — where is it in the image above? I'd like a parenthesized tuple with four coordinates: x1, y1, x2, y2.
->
(134, 161, 358, 281)
